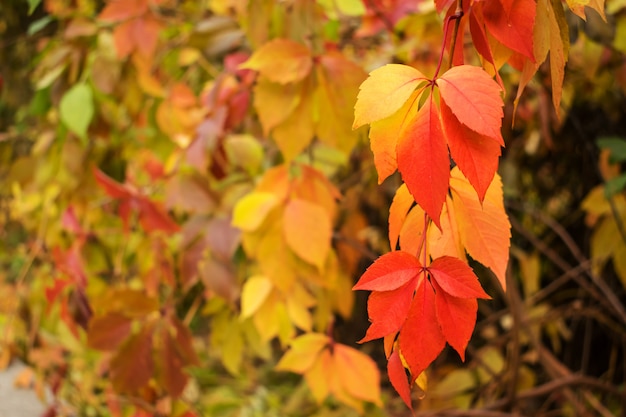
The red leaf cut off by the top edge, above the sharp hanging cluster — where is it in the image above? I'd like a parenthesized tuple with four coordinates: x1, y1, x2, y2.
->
(483, 0, 537, 62)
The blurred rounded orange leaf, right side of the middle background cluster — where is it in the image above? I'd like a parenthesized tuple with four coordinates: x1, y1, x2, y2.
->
(283, 198, 332, 270)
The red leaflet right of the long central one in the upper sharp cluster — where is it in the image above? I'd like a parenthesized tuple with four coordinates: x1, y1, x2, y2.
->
(441, 101, 500, 201)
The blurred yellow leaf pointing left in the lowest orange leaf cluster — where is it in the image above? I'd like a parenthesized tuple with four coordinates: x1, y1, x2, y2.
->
(276, 333, 329, 374)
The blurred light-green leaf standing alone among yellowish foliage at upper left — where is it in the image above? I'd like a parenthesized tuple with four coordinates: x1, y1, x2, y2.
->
(59, 83, 94, 140)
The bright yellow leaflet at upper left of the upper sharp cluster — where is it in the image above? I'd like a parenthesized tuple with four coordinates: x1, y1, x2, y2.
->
(352, 64, 428, 129)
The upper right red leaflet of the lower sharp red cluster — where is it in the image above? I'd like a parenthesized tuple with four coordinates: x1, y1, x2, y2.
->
(428, 256, 491, 298)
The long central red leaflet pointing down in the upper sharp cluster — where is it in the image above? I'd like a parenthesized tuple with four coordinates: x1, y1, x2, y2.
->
(396, 95, 450, 227)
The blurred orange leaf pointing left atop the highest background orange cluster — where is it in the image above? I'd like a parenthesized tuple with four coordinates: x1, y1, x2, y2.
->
(239, 39, 313, 84)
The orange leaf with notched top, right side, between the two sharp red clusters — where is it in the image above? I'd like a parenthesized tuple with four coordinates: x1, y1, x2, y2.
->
(450, 168, 511, 289)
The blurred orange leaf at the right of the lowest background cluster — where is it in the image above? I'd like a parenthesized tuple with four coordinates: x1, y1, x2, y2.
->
(333, 343, 382, 406)
